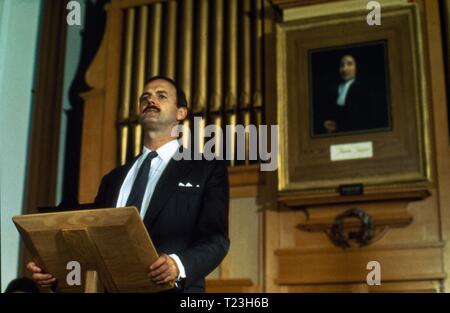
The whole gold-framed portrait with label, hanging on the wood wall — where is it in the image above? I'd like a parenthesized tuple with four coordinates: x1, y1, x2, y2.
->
(277, 3, 431, 192)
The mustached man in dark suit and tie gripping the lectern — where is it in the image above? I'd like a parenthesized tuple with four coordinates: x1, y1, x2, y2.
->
(27, 76, 229, 292)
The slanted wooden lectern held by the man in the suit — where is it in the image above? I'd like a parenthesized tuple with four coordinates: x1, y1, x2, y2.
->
(13, 207, 174, 292)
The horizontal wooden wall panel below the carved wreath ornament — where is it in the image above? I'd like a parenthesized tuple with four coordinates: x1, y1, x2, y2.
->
(275, 242, 445, 285)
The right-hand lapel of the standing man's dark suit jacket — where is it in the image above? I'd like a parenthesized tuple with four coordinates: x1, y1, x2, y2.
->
(144, 158, 191, 227)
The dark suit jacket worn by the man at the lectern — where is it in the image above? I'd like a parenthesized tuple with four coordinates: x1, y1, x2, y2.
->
(95, 147, 230, 292)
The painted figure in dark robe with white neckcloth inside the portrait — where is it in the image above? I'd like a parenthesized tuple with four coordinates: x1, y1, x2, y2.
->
(318, 54, 388, 133)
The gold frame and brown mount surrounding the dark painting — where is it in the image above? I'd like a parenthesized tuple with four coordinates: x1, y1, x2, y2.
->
(277, 3, 431, 192)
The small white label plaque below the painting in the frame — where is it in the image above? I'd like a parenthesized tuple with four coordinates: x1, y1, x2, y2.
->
(330, 141, 373, 161)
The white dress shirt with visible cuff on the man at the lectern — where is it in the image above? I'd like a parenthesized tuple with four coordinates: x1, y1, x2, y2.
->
(116, 139, 186, 279)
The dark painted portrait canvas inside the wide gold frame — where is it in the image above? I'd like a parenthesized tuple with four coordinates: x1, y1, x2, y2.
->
(310, 42, 392, 136)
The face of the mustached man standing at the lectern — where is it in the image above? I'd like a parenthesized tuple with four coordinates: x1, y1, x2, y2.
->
(139, 79, 187, 130)
